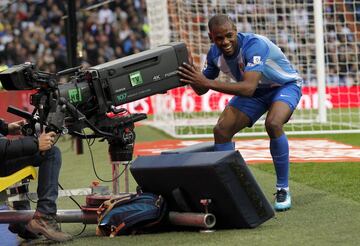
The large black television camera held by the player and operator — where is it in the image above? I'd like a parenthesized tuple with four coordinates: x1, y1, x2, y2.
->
(0, 42, 188, 161)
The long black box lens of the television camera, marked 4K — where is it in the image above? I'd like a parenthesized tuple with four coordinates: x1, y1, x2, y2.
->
(88, 42, 188, 106)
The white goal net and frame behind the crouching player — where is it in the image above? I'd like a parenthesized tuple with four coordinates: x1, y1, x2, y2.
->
(147, 0, 360, 138)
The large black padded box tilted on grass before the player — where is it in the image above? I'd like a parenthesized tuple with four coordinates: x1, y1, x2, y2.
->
(130, 151, 274, 228)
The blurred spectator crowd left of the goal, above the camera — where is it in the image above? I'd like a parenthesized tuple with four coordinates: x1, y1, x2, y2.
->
(0, 0, 149, 72)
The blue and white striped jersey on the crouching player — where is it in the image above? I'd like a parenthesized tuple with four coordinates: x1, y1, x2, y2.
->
(203, 33, 302, 87)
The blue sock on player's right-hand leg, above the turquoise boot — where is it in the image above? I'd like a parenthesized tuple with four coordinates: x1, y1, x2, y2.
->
(270, 134, 289, 188)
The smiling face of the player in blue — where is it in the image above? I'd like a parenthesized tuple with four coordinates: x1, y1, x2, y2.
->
(209, 22, 238, 56)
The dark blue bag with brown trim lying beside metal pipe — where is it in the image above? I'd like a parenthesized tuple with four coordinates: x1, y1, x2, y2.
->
(96, 193, 166, 237)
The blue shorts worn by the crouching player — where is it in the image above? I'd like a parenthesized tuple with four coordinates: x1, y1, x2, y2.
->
(228, 83, 301, 126)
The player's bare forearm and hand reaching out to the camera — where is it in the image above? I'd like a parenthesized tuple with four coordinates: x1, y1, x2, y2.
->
(179, 64, 262, 97)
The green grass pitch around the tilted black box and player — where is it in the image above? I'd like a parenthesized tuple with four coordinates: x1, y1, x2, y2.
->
(23, 126, 360, 246)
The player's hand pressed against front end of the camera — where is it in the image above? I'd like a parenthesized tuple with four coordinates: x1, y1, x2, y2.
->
(178, 63, 209, 88)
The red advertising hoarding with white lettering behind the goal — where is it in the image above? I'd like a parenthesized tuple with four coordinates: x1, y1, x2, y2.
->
(0, 86, 360, 121)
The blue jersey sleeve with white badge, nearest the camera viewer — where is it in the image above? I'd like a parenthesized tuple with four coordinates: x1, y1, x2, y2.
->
(244, 38, 270, 72)
